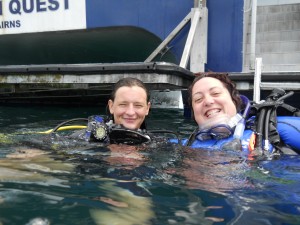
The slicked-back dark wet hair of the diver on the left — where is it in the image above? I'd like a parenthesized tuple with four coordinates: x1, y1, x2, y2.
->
(110, 77, 150, 103)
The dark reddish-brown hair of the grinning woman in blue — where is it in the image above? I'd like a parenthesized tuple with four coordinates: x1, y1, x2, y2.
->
(188, 73, 242, 112)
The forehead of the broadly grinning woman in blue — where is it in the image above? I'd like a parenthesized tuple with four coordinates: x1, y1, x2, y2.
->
(192, 77, 224, 94)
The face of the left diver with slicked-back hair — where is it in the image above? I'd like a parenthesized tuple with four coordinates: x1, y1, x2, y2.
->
(108, 86, 150, 129)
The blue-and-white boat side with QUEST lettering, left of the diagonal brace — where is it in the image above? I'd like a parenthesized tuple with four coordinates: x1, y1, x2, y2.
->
(0, 0, 194, 65)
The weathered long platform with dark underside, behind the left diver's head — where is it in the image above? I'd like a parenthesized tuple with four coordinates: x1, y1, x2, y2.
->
(0, 62, 195, 105)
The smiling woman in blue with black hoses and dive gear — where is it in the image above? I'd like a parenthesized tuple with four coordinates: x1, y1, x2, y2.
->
(183, 73, 299, 158)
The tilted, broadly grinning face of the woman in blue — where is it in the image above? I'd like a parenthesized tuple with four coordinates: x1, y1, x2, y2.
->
(192, 77, 237, 126)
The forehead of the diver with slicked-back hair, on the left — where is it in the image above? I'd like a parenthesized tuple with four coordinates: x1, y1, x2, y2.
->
(115, 86, 147, 101)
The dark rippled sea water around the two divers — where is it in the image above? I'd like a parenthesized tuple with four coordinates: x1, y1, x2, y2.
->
(0, 106, 300, 225)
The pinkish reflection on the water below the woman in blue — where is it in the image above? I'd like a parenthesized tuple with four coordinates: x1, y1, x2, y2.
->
(165, 148, 252, 194)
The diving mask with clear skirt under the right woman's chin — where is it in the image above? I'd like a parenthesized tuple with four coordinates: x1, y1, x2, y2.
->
(196, 113, 242, 141)
